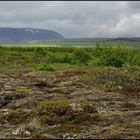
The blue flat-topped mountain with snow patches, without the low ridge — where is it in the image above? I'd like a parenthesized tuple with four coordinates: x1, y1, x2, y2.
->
(0, 28, 64, 43)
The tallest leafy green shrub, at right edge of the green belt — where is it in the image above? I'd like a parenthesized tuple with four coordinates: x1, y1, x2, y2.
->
(94, 45, 135, 67)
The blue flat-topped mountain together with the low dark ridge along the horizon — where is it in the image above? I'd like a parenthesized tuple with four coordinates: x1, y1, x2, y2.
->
(0, 28, 140, 43)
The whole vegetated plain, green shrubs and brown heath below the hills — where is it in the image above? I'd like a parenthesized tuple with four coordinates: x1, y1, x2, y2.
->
(0, 42, 140, 139)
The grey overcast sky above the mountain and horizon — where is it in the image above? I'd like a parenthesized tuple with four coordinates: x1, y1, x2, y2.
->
(0, 1, 140, 38)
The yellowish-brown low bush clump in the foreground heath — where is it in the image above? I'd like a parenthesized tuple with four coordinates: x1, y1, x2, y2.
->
(32, 99, 97, 126)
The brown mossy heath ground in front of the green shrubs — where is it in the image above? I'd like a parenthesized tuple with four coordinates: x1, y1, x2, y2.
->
(0, 68, 140, 139)
